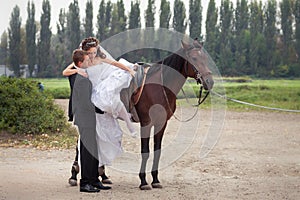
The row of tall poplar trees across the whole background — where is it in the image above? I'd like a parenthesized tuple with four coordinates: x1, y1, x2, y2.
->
(0, 0, 300, 78)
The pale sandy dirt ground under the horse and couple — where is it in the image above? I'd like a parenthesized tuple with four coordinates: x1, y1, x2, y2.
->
(0, 101, 300, 200)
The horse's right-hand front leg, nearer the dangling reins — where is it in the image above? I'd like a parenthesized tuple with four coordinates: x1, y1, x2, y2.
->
(151, 123, 167, 188)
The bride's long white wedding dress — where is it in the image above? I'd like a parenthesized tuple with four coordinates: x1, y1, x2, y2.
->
(87, 56, 133, 167)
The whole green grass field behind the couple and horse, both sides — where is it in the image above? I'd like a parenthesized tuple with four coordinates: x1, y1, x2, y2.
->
(36, 78, 300, 110)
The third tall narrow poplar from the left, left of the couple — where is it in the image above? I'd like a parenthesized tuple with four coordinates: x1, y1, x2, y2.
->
(38, 0, 52, 77)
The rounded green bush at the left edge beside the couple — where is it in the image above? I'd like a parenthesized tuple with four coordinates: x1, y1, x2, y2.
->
(0, 77, 67, 134)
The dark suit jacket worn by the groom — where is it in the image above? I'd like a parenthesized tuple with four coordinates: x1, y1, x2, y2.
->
(72, 74, 96, 129)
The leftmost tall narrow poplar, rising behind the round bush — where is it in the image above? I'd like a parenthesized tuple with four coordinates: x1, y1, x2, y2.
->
(8, 6, 22, 77)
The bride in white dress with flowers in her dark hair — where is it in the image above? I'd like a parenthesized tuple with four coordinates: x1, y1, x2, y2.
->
(81, 37, 137, 166)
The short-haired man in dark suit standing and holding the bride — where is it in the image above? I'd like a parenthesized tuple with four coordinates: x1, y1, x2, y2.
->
(72, 49, 111, 192)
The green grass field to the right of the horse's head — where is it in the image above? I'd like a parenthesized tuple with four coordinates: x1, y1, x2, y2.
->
(209, 77, 300, 110)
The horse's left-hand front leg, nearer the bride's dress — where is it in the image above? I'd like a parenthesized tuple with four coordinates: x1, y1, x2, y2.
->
(139, 126, 151, 190)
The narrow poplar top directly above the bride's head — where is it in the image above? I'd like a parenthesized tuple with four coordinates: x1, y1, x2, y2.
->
(84, 0, 94, 37)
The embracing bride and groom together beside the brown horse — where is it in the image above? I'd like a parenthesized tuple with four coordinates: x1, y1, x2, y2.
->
(63, 37, 137, 192)
